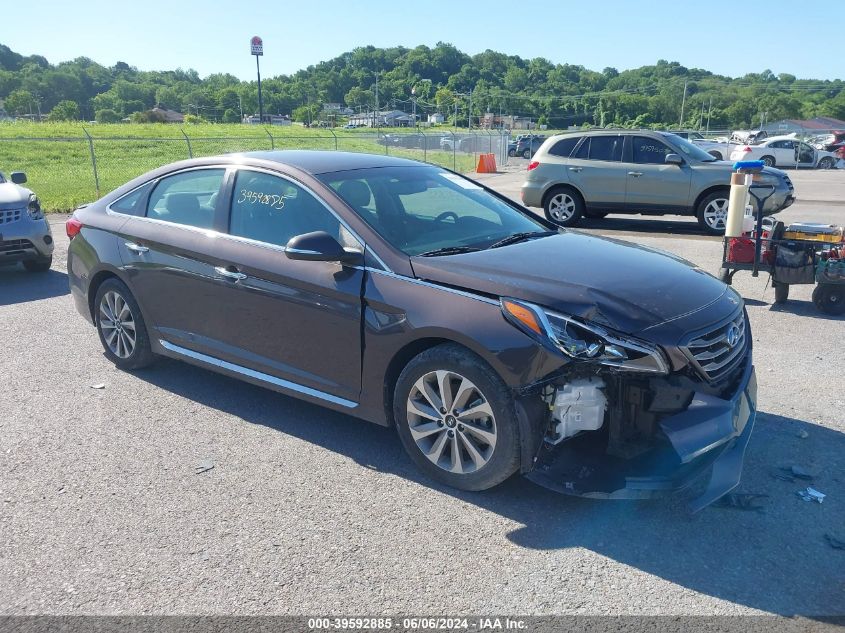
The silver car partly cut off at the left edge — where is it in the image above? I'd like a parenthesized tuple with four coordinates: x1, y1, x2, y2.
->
(0, 171, 53, 272)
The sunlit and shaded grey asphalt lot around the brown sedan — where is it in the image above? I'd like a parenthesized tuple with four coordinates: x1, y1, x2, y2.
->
(0, 166, 845, 616)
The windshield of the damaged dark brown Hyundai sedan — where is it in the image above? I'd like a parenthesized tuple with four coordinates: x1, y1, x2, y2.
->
(318, 166, 548, 255)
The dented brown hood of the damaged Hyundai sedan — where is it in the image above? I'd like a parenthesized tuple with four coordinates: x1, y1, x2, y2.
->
(411, 231, 727, 334)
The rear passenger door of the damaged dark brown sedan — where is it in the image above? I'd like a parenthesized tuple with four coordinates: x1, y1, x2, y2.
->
(119, 167, 227, 358)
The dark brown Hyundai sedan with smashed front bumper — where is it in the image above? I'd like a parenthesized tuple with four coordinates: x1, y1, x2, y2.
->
(67, 148, 757, 510)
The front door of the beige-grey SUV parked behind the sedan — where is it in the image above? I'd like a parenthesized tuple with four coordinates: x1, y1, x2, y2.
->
(623, 135, 692, 212)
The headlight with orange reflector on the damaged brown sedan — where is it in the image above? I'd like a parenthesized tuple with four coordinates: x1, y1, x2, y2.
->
(501, 298, 669, 374)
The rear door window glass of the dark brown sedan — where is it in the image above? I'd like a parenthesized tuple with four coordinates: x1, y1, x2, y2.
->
(147, 169, 226, 229)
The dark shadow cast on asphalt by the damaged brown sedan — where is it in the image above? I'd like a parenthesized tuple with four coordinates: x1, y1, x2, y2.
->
(137, 360, 845, 616)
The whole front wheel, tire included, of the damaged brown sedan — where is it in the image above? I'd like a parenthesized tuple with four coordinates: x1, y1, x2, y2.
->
(393, 343, 519, 490)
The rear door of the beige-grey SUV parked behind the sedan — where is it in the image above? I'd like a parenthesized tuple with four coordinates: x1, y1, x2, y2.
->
(566, 134, 626, 210)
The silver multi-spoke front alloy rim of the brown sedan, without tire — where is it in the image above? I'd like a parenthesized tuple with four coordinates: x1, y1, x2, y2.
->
(407, 370, 497, 474)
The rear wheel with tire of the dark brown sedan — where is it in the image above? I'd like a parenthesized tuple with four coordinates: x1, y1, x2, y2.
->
(94, 278, 155, 370)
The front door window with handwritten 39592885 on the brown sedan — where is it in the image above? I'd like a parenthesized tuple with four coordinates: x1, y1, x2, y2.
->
(229, 169, 359, 248)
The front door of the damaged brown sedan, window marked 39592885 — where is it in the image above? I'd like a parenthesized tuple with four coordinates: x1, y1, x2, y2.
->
(206, 168, 364, 402)
